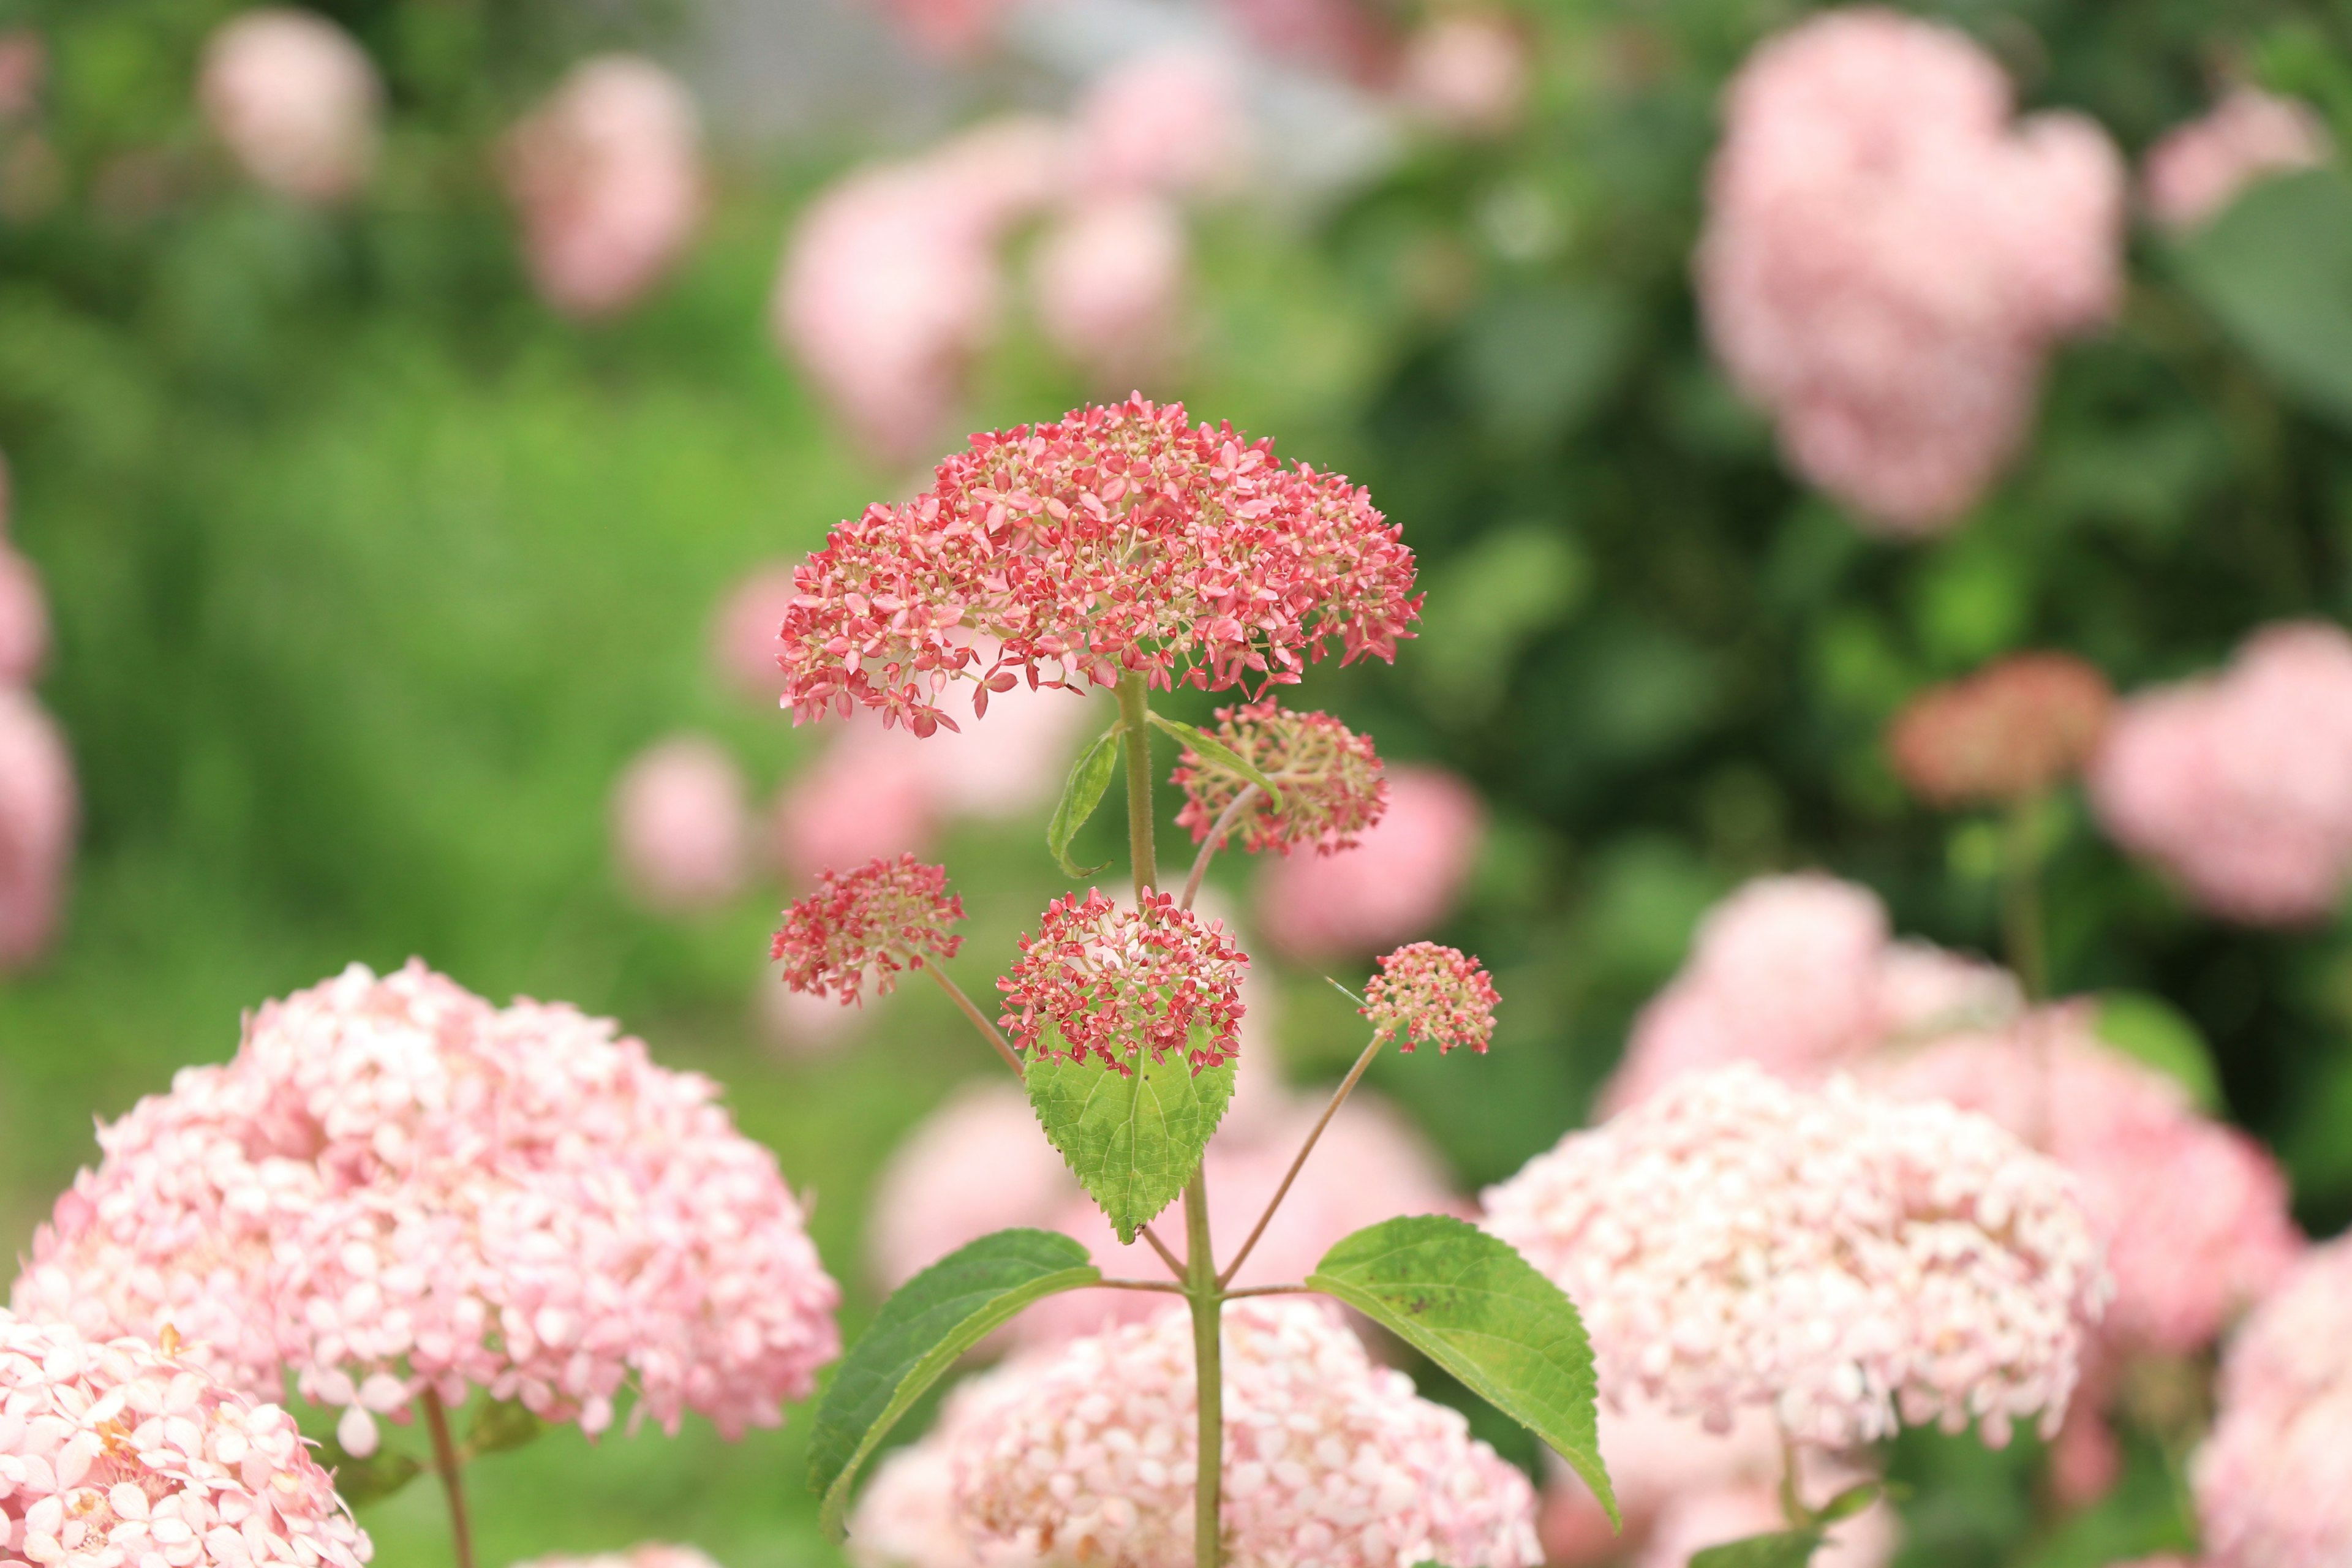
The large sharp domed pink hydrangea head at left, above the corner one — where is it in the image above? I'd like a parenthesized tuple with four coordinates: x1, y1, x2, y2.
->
(14, 964, 840, 1453)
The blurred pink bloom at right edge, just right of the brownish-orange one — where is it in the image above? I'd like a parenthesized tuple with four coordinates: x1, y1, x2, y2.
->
(2091, 620, 2352, 926)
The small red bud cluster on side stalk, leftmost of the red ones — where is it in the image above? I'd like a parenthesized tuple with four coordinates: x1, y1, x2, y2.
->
(769, 856, 964, 1006)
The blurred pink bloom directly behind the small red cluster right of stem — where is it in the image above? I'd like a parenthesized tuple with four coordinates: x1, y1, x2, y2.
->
(1256, 766, 1487, 959)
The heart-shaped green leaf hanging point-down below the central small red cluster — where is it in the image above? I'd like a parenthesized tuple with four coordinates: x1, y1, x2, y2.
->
(1028, 1030, 1232, 1242)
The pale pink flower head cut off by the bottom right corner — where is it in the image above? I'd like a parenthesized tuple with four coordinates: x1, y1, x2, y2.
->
(2192, 1237, 2352, 1568)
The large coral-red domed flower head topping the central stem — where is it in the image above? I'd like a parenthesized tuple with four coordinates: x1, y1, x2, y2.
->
(781, 398, 1420, 733)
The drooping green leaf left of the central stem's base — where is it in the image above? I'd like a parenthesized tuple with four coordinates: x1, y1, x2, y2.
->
(809, 1229, 1103, 1540)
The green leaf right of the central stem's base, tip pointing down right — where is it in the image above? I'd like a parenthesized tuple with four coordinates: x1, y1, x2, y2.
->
(1308, 1215, 1618, 1523)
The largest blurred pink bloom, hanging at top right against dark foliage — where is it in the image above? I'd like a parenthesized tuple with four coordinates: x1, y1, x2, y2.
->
(1698, 7, 2124, 533)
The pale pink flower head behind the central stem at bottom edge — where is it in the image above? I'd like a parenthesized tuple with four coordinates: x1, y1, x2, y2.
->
(943, 1300, 1538, 1568)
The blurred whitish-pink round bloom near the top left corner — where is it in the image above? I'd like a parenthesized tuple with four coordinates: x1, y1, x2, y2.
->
(198, 5, 383, 205)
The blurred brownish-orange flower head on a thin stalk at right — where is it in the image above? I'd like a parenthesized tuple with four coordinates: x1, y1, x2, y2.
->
(1887, 654, 2114, 806)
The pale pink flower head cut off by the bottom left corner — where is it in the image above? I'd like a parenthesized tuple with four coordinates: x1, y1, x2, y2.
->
(0, 1312, 374, 1568)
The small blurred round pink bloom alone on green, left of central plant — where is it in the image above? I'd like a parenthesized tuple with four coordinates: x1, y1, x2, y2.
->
(611, 736, 753, 910)
